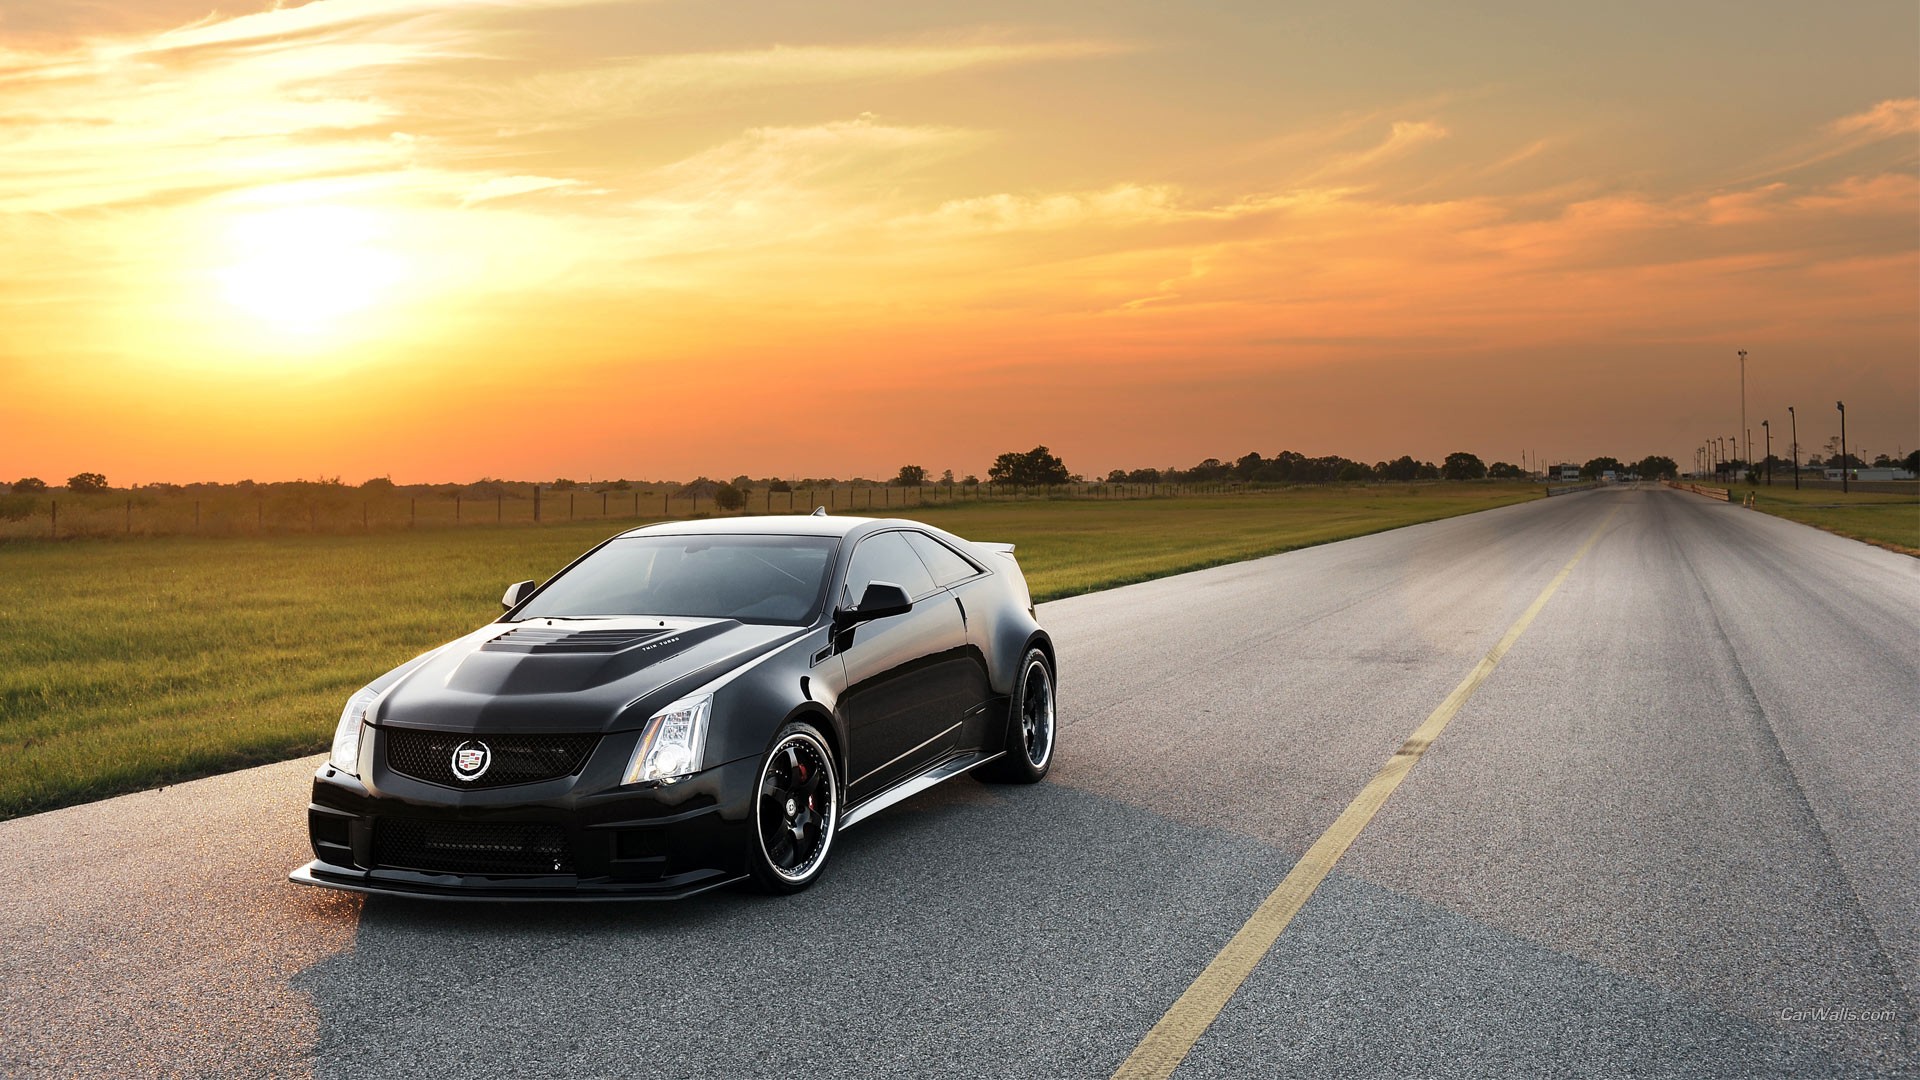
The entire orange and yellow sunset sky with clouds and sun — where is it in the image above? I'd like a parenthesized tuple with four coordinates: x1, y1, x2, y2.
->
(0, 0, 1920, 484)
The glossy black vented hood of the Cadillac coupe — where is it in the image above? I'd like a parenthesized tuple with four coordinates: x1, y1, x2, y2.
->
(372, 617, 804, 732)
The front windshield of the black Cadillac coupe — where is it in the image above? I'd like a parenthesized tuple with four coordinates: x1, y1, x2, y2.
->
(516, 536, 837, 626)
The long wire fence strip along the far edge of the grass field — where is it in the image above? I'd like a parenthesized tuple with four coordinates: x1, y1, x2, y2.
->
(0, 482, 1269, 540)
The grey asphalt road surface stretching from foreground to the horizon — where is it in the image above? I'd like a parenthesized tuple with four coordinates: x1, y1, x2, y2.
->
(0, 488, 1920, 1078)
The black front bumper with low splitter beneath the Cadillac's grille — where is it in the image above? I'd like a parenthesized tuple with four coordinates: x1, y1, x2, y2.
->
(288, 745, 758, 899)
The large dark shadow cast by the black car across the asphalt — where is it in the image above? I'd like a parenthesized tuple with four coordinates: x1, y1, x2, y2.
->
(296, 782, 1889, 1076)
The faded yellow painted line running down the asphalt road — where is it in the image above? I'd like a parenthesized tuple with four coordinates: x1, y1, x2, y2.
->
(1114, 511, 1617, 1080)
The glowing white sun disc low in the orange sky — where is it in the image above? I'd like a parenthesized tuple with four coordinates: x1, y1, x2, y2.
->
(219, 206, 405, 338)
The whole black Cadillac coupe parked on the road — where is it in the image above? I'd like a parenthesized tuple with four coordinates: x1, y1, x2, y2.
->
(292, 513, 1056, 899)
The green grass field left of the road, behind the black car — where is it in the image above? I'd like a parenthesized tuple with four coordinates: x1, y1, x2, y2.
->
(0, 484, 1540, 817)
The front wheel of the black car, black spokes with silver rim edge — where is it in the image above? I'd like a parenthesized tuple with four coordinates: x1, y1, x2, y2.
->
(747, 723, 841, 894)
